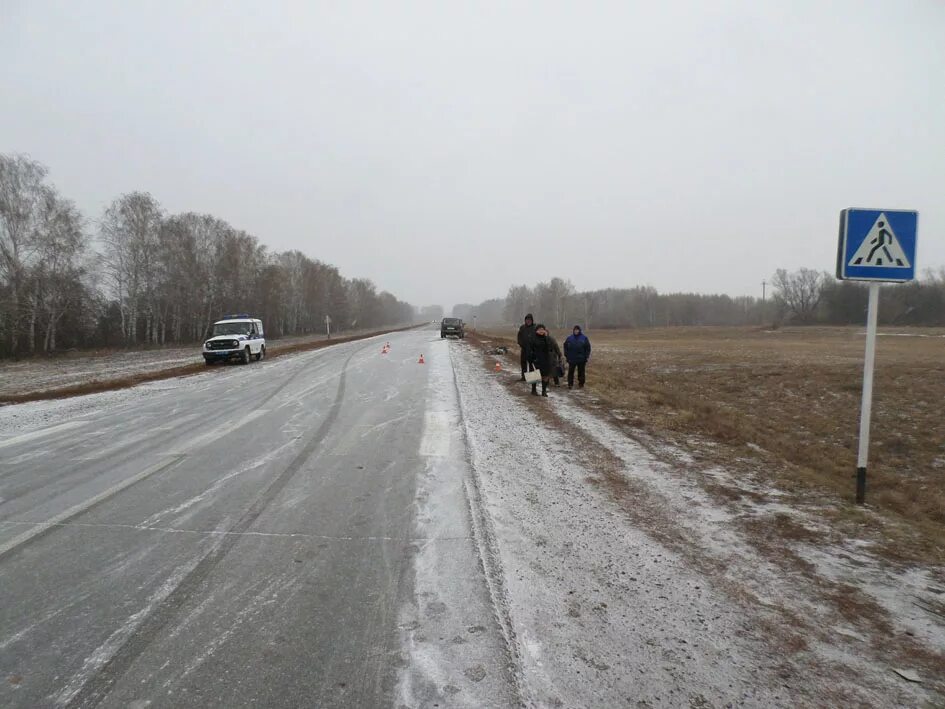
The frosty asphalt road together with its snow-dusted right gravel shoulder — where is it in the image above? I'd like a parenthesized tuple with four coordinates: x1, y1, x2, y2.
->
(0, 330, 941, 709)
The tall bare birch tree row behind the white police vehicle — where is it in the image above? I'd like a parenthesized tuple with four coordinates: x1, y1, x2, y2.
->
(0, 154, 415, 357)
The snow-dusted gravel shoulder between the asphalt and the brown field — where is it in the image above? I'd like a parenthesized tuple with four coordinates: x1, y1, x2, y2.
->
(454, 345, 937, 706)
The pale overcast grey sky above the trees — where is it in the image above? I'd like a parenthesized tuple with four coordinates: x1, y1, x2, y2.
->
(0, 0, 945, 308)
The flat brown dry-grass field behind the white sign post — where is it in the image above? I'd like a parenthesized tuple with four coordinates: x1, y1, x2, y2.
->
(480, 327, 945, 560)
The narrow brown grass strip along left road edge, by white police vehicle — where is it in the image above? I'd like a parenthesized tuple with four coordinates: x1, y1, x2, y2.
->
(0, 326, 414, 406)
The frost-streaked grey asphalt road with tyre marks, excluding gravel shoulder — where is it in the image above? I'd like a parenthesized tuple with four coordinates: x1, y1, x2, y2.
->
(0, 329, 516, 707)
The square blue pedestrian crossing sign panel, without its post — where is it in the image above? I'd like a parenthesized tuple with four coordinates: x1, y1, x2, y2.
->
(837, 209, 919, 283)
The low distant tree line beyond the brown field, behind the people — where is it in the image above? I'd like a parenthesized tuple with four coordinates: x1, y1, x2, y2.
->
(452, 268, 945, 328)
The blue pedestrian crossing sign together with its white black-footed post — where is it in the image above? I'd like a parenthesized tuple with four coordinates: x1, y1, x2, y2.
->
(837, 208, 919, 505)
